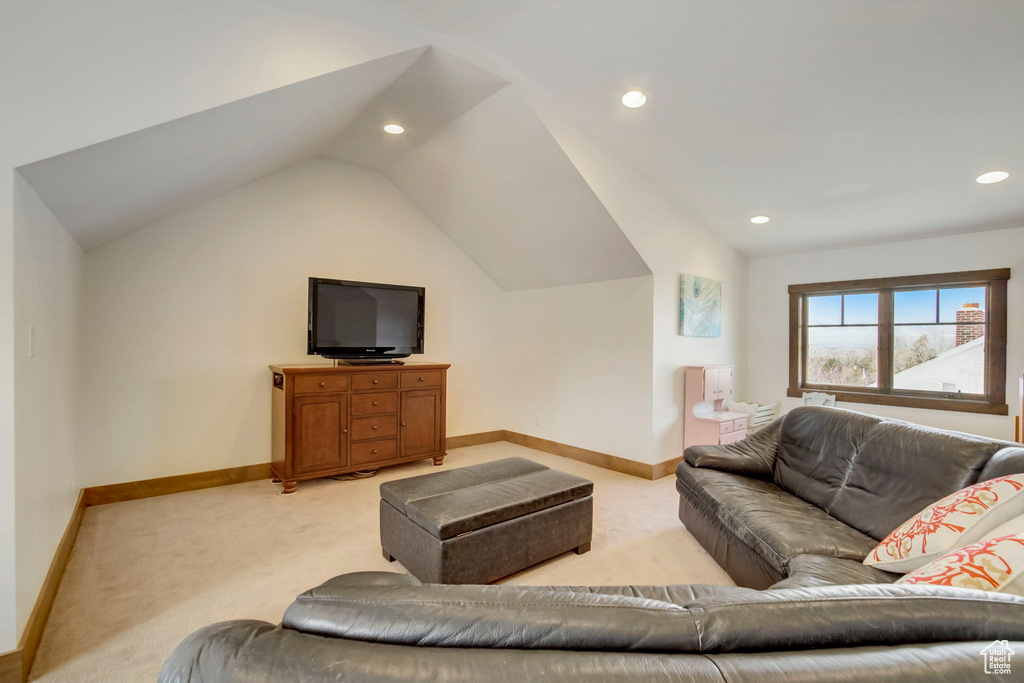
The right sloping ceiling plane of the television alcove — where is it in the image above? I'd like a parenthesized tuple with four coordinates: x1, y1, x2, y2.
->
(385, 88, 650, 291)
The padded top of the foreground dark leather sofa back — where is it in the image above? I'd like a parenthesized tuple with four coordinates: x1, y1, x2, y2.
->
(282, 572, 1024, 653)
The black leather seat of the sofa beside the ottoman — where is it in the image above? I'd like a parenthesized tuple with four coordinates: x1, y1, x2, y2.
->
(676, 465, 876, 574)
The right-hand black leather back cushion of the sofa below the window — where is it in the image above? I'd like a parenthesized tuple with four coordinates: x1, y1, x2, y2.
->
(825, 421, 1001, 541)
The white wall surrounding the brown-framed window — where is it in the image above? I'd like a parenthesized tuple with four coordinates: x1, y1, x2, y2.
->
(748, 227, 1024, 439)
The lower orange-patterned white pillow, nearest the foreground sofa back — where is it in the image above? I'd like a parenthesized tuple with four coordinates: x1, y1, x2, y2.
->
(896, 515, 1024, 596)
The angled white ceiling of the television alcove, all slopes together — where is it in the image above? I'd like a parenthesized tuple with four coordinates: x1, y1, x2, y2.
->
(18, 48, 650, 291)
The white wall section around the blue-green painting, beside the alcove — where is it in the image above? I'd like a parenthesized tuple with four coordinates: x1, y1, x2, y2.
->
(531, 101, 746, 462)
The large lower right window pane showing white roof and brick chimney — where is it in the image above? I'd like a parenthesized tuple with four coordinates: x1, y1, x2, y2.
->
(893, 325, 985, 394)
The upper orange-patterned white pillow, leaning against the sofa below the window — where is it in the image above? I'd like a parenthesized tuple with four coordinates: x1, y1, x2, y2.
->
(864, 474, 1024, 573)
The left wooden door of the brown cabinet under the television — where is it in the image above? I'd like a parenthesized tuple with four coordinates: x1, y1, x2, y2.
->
(292, 395, 348, 474)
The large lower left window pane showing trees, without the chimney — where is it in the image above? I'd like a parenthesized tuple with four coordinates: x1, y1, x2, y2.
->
(806, 327, 879, 387)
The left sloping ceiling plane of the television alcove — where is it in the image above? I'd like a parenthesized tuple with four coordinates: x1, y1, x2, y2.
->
(18, 47, 426, 251)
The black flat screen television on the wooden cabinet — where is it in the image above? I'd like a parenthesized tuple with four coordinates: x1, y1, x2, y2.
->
(306, 278, 425, 360)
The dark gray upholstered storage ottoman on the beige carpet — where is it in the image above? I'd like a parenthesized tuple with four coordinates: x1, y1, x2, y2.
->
(381, 458, 594, 584)
